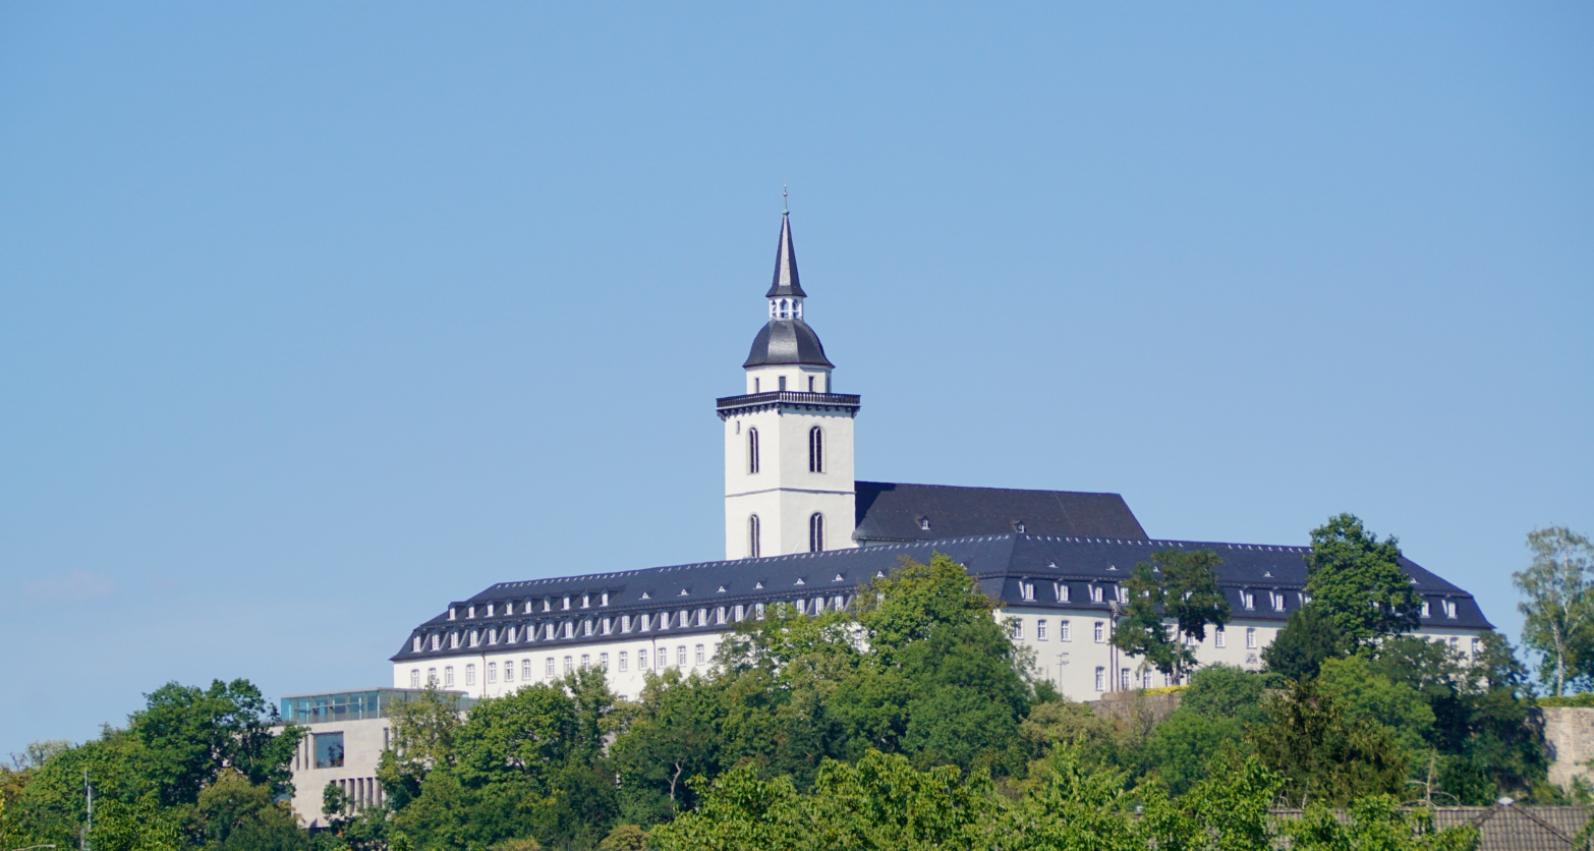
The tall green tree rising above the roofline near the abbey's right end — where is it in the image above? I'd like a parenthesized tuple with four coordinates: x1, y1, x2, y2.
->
(1305, 515, 1422, 647)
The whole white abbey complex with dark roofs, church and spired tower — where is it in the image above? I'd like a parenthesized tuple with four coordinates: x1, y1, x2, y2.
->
(392, 214, 1492, 700)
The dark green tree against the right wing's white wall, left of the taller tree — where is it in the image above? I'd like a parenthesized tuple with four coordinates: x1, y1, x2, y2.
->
(1113, 550, 1229, 676)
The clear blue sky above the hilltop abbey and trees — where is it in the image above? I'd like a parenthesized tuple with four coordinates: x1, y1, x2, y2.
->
(0, 2, 1594, 752)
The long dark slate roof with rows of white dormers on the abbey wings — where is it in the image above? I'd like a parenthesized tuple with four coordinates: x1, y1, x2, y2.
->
(392, 534, 1492, 661)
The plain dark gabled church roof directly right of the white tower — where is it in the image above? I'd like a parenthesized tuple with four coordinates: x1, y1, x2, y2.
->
(853, 481, 1146, 543)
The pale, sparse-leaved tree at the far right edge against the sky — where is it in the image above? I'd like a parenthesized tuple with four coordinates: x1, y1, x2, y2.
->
(1511, 526, 1594, 696)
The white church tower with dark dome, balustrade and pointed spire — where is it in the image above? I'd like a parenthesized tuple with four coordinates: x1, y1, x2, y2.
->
(716, 210, 859, 559)
